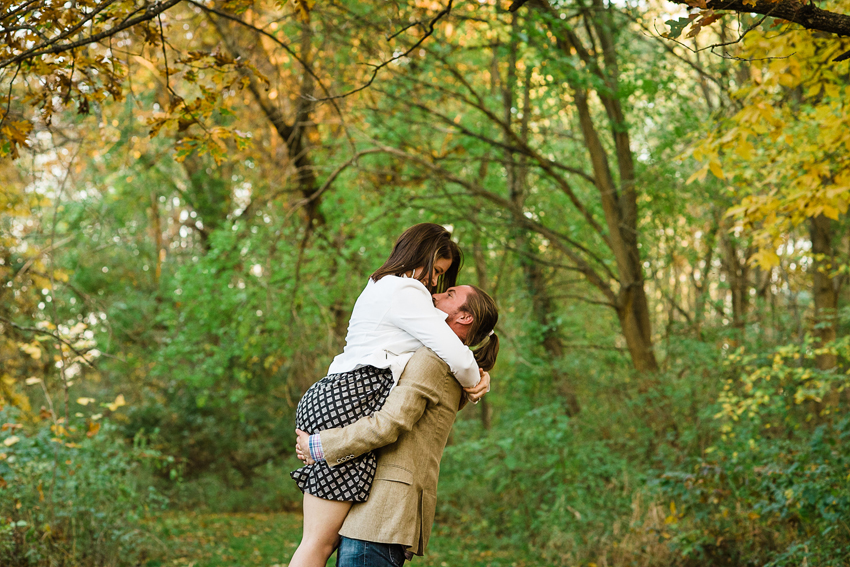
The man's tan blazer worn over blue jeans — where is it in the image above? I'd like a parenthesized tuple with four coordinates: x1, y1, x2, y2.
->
(321, 347, 463, 555)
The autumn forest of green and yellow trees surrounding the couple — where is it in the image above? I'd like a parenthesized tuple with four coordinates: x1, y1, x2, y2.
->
(0, 0, 850, 567)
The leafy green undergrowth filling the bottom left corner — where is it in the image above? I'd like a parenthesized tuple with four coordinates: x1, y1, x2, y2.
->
(0, 407, 165, 567)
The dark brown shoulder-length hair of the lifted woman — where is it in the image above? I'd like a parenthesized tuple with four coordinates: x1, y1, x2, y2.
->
(370, 222, 463, 293)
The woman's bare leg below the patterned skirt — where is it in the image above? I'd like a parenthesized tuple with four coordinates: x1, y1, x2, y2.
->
(289, 492, 351, 567)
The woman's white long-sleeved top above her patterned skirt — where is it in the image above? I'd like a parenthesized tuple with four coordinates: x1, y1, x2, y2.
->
(328, 276, 481, 388)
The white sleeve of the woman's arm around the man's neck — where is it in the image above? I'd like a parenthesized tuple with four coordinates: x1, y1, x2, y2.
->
(387, 280, 481, 388)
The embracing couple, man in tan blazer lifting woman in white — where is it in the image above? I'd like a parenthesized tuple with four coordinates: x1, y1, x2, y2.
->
(289, 223, 499, 567)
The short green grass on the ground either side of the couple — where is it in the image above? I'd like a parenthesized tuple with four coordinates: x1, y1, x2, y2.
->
(142, 512, 540, 567)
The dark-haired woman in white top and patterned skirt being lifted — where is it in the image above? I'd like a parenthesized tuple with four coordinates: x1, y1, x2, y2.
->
(289, 223, 490, 567)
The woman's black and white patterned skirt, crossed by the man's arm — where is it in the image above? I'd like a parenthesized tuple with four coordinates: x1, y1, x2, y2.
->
(289, 366, 393, 502)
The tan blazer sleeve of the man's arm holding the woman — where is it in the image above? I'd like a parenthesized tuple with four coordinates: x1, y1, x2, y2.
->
(320, 348, 448, 467)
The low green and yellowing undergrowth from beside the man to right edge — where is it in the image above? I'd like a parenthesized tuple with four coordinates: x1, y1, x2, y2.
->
(430, 326, 850, 566)
